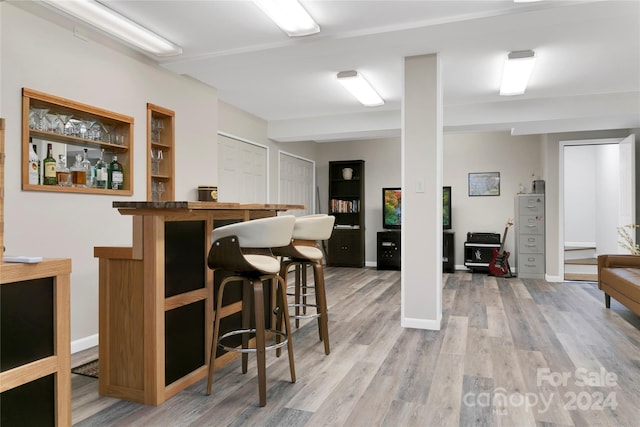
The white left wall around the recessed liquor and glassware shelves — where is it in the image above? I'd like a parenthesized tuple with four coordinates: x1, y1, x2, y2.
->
(0, 2, 218, 345)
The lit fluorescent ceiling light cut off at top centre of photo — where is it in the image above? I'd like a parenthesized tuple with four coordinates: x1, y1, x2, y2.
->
(253, 0, 320, 37)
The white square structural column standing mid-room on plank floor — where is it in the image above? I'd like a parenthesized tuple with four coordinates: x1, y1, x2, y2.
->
(401, 54, 442, 330)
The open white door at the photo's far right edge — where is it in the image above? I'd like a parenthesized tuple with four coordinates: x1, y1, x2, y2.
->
(618, 134, 636, 251)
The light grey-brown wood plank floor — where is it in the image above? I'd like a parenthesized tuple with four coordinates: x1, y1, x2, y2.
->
(72, 268, 640, 427)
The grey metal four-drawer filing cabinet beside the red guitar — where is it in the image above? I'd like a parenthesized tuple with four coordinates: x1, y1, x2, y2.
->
(515, 194, 545, 279)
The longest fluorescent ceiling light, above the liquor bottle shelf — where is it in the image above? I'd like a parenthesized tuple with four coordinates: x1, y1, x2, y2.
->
(42, 0, 182, 56)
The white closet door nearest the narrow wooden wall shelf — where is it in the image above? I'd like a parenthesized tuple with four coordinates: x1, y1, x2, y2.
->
(218, 134, 268, 203)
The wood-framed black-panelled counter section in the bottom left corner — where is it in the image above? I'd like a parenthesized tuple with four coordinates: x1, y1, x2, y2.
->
(0, 258, 71, 426)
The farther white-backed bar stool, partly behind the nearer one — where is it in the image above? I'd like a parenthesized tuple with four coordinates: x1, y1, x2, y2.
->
(273, 214, 335, 354)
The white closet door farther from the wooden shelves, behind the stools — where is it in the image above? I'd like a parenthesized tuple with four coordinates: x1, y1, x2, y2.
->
(278, 151, 316, 216)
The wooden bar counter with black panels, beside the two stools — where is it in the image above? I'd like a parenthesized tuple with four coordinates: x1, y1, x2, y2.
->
(94, 201, 304, 405)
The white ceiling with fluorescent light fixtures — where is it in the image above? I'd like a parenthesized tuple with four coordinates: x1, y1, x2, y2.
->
(20, 0, 640, 142)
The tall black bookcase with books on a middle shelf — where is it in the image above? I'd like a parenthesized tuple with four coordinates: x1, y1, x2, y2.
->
(327, 160, 365, 267)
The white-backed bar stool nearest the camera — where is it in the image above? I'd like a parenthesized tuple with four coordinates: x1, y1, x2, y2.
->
(207, 215, 296, 406)
